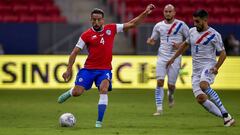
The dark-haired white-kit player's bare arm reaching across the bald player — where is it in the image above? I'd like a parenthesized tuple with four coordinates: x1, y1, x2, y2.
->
(166, 41, 189, 68)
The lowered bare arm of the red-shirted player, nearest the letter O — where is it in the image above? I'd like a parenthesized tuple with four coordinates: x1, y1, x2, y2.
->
(62, 47, 80, 81)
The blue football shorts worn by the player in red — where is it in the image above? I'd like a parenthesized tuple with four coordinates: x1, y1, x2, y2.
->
(75, 68, 112, 91)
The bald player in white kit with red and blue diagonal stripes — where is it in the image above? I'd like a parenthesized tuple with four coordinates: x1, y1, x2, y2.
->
(147, 4, 189, 116)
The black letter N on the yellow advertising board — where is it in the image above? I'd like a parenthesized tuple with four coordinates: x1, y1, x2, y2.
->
(32, 64, 49, 83)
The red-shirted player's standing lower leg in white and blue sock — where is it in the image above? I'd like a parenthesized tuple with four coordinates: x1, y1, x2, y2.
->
(95, 94, 108, 128)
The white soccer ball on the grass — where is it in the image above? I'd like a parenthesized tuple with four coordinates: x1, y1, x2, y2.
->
(59, 113, 76, 127)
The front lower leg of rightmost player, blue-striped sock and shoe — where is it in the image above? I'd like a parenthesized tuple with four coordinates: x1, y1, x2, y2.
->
(205, 87, 235, 127)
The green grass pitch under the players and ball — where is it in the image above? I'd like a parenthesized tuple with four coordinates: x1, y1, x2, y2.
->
(0, 90, 240, 135)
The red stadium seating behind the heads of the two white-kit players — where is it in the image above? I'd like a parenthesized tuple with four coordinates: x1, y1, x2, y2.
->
(107, 0, 240, 24)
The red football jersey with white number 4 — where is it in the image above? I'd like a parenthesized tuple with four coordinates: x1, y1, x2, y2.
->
(80, 24, 120, 70)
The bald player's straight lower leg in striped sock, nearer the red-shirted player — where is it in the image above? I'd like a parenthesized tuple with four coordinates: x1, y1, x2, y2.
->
(153, 87, 164, 116)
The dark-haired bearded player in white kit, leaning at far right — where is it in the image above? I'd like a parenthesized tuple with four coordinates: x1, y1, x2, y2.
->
(167, 9, 235, 126)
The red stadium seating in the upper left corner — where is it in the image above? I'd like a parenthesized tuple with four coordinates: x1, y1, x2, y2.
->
(0, 0, 66, 23)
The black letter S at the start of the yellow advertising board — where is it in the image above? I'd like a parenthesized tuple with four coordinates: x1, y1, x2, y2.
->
(2, 62, 17, 83)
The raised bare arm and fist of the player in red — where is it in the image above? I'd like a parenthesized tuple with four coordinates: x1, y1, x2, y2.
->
(123, 4, 155, 31)
